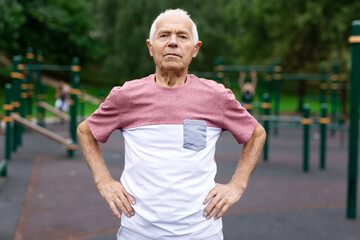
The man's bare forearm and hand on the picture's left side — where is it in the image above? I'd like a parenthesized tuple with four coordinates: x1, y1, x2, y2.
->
(77, 121, 136, 217)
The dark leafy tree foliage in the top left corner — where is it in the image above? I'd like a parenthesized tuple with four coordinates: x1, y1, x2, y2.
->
(0, 0, 100, 63)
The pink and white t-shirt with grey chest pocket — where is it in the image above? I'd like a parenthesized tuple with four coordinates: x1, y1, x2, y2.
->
(87, 74, 257, 240)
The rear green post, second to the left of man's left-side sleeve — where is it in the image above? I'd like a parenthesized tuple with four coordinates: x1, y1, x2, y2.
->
(36, 50, 45, 127)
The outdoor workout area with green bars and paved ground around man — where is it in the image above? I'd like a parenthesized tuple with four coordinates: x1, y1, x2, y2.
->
(0, 21, 360, 240)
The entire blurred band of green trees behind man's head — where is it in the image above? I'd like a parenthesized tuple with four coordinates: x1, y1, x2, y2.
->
(0, 0, 360, 87)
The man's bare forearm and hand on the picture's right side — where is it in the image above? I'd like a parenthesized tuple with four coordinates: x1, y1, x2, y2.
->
(204, 124, 266, 219)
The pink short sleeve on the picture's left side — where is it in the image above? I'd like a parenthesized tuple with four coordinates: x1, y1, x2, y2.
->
(86, 87, 122, 143)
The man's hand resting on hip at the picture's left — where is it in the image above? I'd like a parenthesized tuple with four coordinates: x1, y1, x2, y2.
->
(96, 178, 136, 218)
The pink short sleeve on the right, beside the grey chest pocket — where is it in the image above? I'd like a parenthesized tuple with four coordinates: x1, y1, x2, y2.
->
(222, 89, 258, 144)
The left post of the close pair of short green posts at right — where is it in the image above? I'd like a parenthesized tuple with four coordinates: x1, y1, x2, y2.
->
(302, 104, 312, 172)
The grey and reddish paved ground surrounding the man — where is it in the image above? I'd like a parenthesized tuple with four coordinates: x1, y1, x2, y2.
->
(0, 125, 360, 240)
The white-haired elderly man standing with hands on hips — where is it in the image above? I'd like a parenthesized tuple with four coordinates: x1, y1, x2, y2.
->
(78, 9, 266, 240)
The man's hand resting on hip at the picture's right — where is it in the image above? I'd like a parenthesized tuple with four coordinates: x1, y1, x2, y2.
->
(204, 183, 244, 220)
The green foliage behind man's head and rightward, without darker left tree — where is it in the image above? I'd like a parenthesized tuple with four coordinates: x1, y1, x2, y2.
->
(100, 0, 360, 83)
